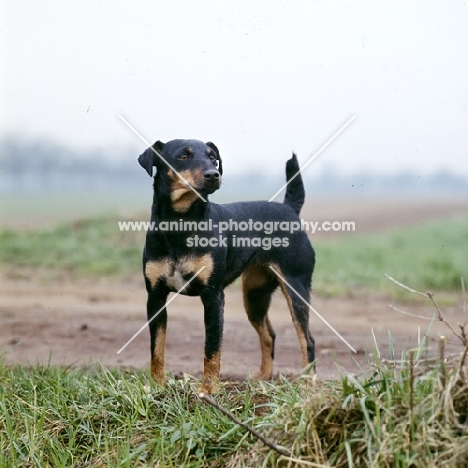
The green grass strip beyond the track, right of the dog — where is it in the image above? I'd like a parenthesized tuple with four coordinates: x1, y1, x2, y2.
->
(314, 217, 468, 295)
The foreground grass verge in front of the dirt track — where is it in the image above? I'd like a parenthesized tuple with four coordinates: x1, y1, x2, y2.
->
(0, 330, 468, 468)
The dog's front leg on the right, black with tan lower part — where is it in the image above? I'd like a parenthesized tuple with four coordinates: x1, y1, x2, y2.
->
(198, 289, 224, 394)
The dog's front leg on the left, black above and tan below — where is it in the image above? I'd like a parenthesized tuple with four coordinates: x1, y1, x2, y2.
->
(146, 291, 167, 386)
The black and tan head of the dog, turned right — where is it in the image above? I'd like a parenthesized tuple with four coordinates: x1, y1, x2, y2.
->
(138, 140, 223, 212)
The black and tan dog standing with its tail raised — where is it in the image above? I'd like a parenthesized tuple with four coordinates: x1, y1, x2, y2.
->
(138, 140, 315, 393)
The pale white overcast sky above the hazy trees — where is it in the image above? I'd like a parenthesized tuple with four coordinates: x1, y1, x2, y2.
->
(0, 0, 468, 176)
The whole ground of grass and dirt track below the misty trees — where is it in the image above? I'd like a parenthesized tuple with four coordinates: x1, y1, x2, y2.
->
(0, 194, 468, 466)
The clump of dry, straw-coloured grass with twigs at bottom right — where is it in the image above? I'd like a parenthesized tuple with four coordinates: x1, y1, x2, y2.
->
(236, 282, 468, 468)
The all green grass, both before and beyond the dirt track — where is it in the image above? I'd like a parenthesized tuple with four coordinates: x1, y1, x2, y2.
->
(0, 211, 468, 468)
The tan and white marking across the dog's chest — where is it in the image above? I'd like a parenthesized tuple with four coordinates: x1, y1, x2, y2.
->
(145, 253, 213, 291)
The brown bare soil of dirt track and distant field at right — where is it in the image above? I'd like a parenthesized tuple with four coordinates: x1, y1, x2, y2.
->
(0, 196, 467, 379)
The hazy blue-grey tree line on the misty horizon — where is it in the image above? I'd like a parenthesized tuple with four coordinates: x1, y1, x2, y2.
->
(0, 136, 468, 194)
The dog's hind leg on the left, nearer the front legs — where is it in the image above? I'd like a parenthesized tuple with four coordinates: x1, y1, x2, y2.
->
(242, 266, 278, 380)
